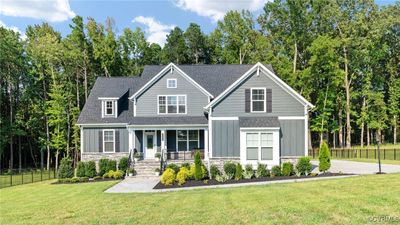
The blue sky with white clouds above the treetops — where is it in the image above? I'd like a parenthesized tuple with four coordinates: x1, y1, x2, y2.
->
(0, 0, 395, 45)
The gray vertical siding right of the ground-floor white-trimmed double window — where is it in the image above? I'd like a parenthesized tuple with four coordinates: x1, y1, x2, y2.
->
(279, 120, 305, 156)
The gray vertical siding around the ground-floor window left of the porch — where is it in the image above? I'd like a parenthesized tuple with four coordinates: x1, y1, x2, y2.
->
(82, 127, 129, 152)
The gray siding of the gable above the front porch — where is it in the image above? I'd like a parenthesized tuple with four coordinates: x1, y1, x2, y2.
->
(136, 70, 208, 117)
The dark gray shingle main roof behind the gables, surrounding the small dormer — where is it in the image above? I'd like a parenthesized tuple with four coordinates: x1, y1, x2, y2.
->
(78, 65, 272, 124)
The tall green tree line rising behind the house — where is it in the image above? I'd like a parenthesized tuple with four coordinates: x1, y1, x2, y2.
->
(0, 0, 400, 171)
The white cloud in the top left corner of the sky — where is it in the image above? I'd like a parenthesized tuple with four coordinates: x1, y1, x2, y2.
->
(0, 0, 75, 22)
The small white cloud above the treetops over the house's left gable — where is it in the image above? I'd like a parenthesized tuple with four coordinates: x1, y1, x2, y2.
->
(132, 16, 175, 46)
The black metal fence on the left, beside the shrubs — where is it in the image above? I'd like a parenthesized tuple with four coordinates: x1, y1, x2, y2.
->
(0, 168, 57, 188)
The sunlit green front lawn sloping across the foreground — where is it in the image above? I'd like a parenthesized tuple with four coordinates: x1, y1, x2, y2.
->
(0, 174, 400, 224)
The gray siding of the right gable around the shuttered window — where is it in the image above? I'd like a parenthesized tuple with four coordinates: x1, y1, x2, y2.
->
(212, 72, 304, 117)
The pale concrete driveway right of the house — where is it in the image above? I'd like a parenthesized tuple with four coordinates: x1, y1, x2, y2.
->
(311, 160, 400, 174)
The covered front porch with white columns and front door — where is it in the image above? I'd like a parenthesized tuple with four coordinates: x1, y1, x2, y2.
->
(128, 126, 208, 161)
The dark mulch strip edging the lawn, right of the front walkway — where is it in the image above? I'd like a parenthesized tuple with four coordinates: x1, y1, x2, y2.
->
(153, 173, 354, 189)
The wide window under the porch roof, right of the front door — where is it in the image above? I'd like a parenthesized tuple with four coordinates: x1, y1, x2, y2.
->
(176, 130, 200, 151)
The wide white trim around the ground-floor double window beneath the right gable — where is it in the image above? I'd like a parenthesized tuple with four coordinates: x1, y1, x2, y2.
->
(240, 128, 280, 168)
